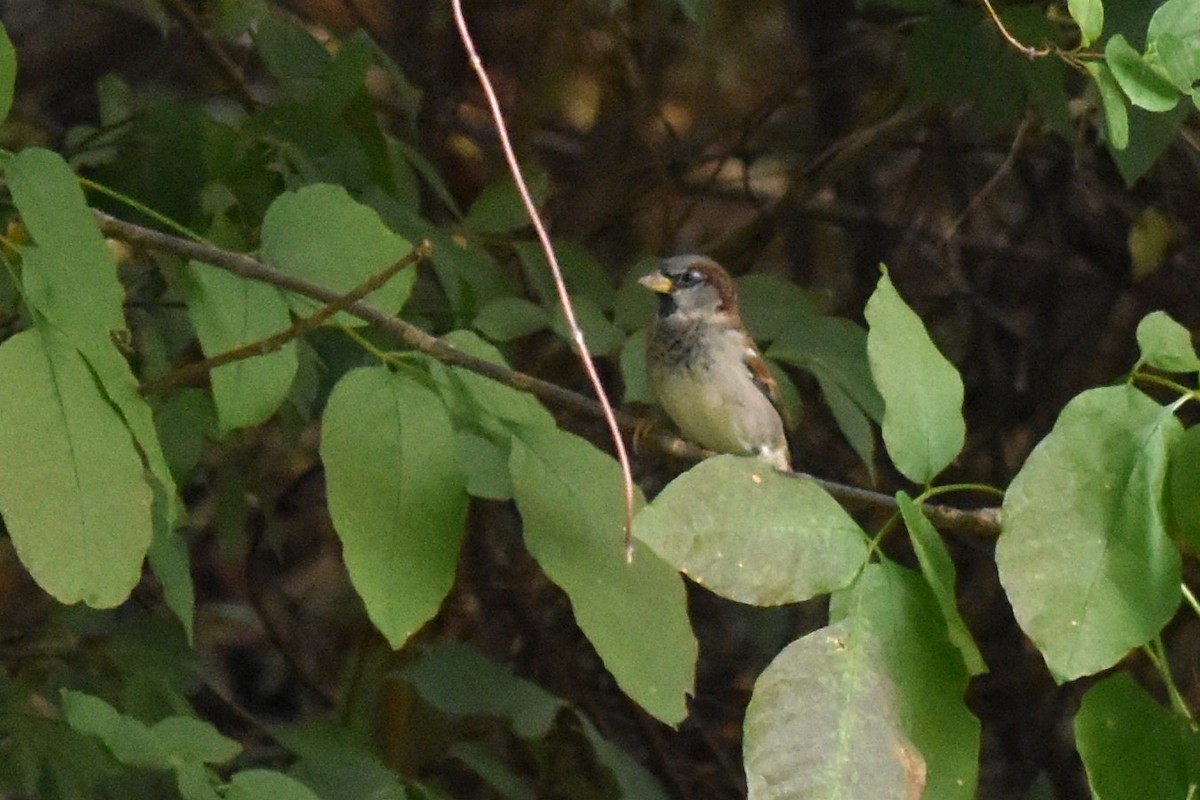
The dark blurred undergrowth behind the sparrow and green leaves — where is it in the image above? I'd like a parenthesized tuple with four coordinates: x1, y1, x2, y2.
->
(0, 0, 1200, 800)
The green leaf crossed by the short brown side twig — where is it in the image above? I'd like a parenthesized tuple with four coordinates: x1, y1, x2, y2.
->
(185, 263, 300, 433)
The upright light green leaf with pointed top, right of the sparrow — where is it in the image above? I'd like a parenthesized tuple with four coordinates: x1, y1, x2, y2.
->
(864, 272, 966, 485)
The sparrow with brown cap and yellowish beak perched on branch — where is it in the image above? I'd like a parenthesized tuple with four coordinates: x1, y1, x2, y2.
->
(638, 255, 791, 471)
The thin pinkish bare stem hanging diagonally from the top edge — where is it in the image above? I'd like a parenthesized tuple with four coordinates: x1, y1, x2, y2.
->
(450, 0, 635, 561)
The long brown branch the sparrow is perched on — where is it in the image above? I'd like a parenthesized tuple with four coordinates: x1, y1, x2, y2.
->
(94, 211, 1000, 539)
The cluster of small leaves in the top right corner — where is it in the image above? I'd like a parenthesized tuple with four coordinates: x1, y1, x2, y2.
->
(840, 0, 1200, 184)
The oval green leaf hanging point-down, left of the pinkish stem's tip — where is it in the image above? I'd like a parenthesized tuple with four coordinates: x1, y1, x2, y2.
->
(320, 367, 467, 648)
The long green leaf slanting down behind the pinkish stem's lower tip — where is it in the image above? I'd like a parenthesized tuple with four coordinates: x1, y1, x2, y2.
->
(509, 429, 696, 724)
